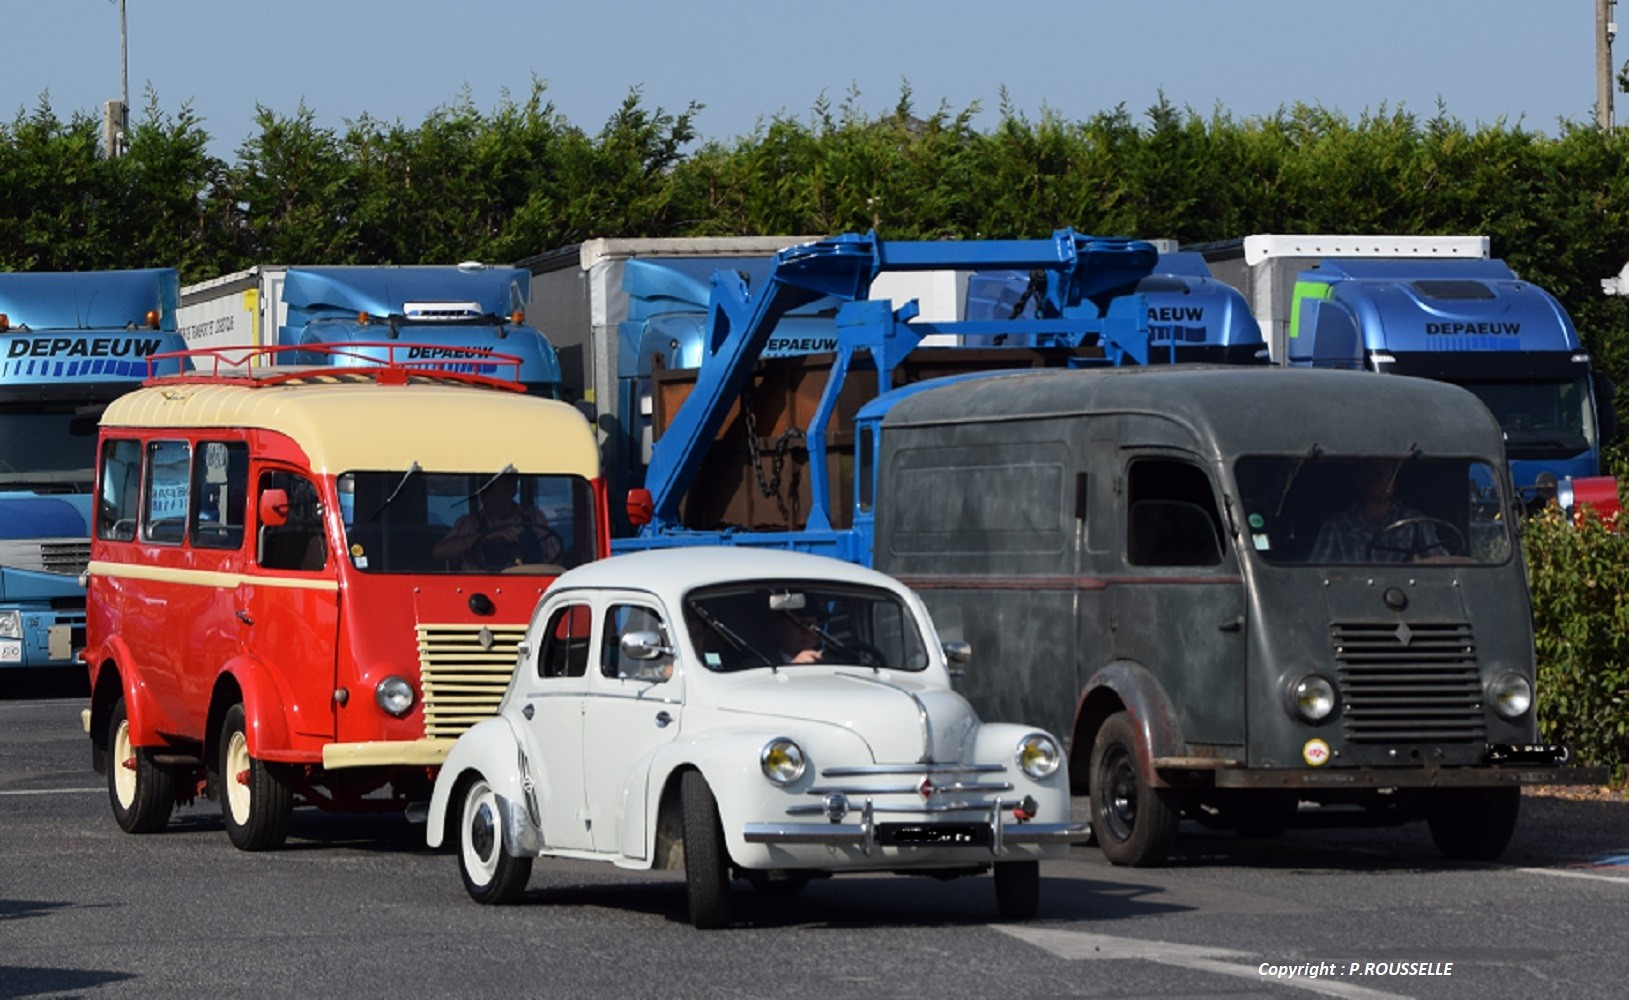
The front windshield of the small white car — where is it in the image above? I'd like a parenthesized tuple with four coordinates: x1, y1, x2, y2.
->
(684, 580, 929, 671)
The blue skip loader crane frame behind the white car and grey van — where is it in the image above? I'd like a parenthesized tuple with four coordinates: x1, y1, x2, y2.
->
(613, 230, 1261, 565)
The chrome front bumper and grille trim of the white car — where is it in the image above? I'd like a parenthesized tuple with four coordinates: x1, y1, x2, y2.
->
(741, 764, 1088, 855)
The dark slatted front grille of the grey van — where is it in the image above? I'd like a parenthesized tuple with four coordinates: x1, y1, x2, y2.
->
(1331, 622, 1487, 743)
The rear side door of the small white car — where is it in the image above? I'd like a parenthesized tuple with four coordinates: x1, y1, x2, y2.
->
(521, 598, 593, 850)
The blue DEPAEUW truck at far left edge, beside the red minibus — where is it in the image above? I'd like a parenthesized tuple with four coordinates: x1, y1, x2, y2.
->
(0, 269, 182, 669)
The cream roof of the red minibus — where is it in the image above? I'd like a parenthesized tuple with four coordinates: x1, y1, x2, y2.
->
(101, 379, 599, 477)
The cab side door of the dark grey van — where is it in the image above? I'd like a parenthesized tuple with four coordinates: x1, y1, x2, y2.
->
(1111, 450, 1246, 744)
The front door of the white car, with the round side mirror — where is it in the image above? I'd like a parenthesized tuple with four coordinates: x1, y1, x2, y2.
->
(583, 594, 684, 858)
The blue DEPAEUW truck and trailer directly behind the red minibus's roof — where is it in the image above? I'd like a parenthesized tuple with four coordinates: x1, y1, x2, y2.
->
(181, 262, 560, 399)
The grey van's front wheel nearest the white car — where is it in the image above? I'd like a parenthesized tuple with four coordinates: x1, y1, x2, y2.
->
(1091, 712, 1178, 868)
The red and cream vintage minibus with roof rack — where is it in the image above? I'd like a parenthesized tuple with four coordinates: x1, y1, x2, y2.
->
(85, 347, 609, 850)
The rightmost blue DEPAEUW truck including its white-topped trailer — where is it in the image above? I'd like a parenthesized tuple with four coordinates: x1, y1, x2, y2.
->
(1194, 235, 1618, 508)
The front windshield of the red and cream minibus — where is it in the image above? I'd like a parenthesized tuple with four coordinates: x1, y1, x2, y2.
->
(336, 464, 596, 575)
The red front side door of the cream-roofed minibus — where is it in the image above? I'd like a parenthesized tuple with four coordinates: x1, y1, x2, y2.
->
(238, 464, 339, 739)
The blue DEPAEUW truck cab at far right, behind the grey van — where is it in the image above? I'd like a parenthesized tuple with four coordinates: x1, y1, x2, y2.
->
(1285, 259, 1614, 495)
